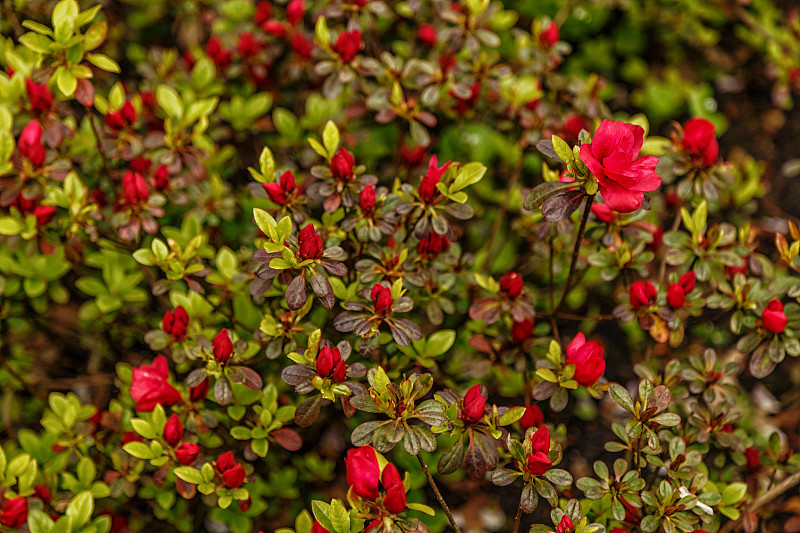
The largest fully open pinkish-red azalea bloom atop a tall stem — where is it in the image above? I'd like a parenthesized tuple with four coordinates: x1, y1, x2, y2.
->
(581, 120, 661, 213)
